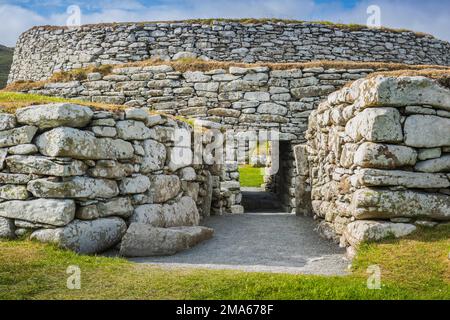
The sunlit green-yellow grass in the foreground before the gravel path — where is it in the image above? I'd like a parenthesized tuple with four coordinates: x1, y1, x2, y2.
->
(0, 225, 450, 299)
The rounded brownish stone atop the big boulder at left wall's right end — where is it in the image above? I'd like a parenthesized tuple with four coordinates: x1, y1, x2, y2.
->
(149, 175, 181, 203)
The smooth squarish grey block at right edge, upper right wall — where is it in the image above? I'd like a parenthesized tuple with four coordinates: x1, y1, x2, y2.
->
(405, 115, 450, 148)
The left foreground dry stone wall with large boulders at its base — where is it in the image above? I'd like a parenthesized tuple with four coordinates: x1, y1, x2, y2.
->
(0, 103, 221, 256)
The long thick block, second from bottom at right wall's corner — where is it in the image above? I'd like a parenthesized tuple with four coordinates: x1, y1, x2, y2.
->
(351, 189, 450, 220)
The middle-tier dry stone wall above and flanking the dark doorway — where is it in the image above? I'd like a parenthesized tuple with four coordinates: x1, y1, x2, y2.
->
(21, 64, 384, 214)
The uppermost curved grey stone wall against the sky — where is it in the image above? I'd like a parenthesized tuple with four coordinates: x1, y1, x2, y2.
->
(9, 21, 450, 83)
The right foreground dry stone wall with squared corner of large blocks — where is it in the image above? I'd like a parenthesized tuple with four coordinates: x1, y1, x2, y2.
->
(306, 76, 450, 255)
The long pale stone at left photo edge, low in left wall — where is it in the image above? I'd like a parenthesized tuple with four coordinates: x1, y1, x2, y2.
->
(0, 199, 75, 227)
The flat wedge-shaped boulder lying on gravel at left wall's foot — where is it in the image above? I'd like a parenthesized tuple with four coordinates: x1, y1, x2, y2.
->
(120, 223, 214, 257)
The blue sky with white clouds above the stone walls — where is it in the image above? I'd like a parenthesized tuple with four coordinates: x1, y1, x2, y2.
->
(0, 0, 450, 46)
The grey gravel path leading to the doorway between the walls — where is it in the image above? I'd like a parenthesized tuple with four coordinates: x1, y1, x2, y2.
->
(130, 212, 348, 275)
